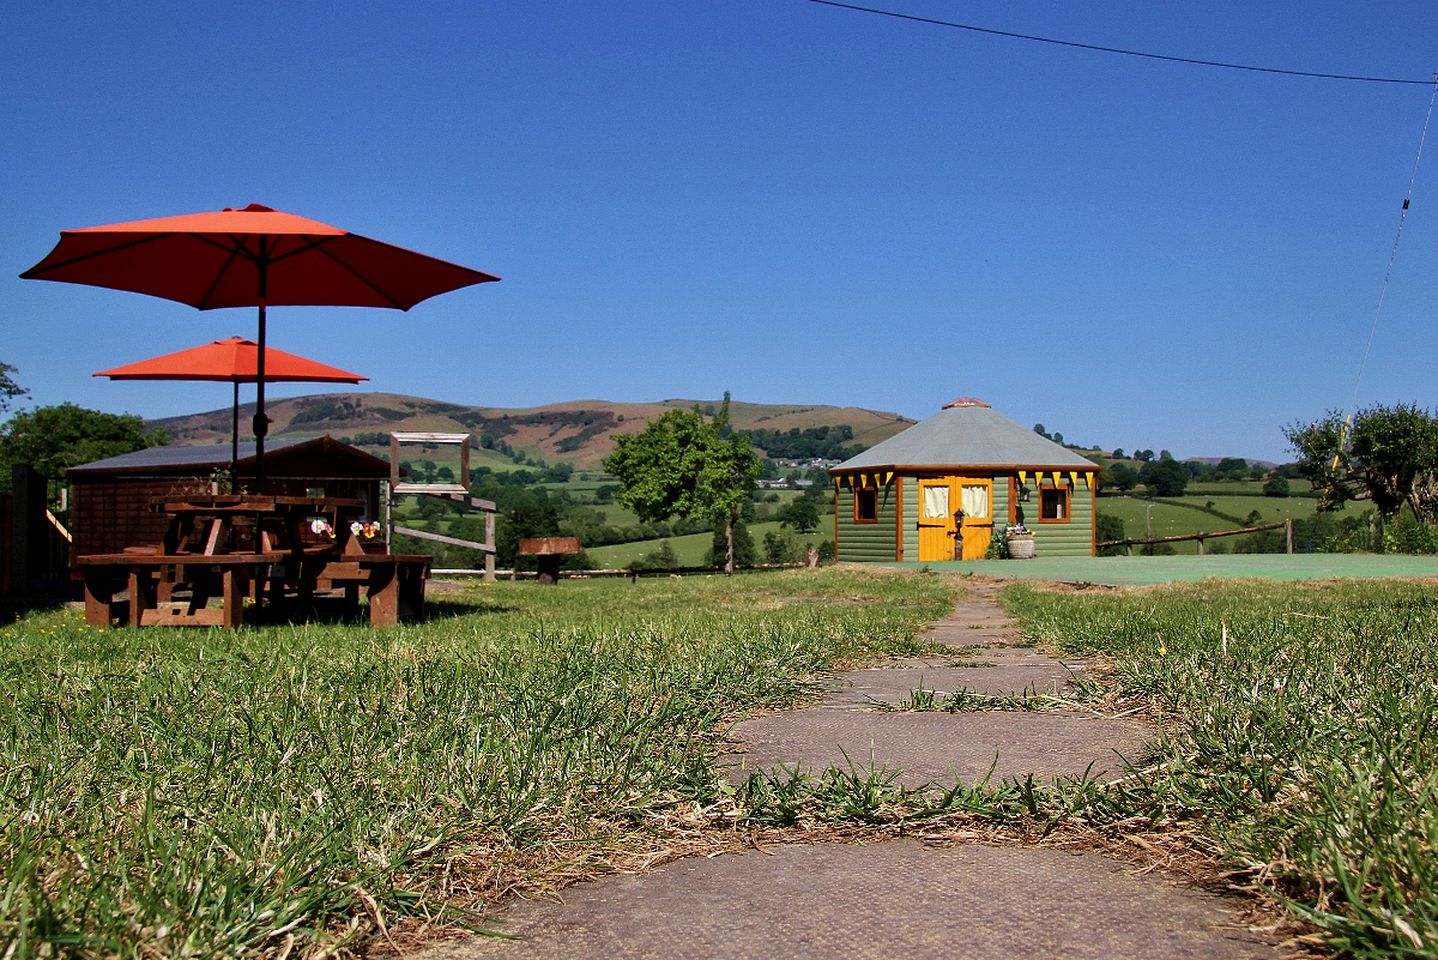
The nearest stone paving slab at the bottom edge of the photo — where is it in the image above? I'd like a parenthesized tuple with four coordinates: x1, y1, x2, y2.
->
(423, 839, 1283, 960)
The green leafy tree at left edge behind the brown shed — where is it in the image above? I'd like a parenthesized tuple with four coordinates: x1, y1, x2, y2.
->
(0, 404, 168, 490)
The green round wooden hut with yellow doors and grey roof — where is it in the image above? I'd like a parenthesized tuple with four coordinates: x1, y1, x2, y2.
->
(830, 397, 1099, 562)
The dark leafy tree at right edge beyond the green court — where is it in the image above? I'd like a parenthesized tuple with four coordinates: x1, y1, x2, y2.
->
(1283, 404, 1438, 520)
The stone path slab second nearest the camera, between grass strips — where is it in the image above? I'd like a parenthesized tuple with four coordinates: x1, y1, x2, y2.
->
(726, 709, 1153, 788)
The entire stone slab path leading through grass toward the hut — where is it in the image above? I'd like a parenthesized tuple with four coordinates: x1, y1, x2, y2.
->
(424, 582, 1284, 960)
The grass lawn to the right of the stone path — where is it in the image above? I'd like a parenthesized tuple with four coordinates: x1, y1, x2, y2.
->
(1004, 582, 1438, 957)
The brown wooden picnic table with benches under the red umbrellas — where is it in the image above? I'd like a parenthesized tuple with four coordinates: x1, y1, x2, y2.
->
(76, 494, 433, 627)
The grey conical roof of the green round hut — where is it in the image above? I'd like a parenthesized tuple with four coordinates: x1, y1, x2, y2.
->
(834, 398, 1097, 471)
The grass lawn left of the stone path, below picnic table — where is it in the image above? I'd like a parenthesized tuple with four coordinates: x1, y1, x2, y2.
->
(0, 571, 953, 959)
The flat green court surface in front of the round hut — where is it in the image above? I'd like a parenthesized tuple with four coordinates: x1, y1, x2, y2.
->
(890, 553, 1438, 586)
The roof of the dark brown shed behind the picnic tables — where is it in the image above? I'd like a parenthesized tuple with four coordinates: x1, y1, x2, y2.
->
(65, 434, 390, 479)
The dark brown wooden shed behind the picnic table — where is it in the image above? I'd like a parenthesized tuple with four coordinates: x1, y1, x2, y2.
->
(65, 434, 390, 556)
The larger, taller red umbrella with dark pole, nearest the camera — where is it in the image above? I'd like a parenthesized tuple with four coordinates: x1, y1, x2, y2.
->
(20, 204, 499, 490)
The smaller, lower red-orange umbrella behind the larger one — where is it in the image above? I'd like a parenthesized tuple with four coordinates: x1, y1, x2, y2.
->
(92, 336, 370, 469)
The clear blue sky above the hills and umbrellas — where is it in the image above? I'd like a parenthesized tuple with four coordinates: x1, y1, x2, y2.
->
(0, 0, 1438, 458)
